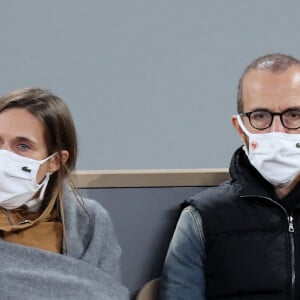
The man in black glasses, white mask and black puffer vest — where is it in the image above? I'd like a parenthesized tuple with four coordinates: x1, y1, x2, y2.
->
(160, 54, 300, 300)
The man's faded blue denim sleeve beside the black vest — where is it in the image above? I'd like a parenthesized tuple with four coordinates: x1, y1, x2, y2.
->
(160, 206, 205, 300)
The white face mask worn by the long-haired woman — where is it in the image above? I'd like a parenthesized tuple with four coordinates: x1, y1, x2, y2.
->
(0, 150, 54, 209)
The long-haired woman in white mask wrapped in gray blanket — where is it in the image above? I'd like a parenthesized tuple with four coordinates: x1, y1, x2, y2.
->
(0, 88, 128, 300)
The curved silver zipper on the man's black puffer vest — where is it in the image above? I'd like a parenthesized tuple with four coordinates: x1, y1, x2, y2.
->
(240, 195, 296, 300)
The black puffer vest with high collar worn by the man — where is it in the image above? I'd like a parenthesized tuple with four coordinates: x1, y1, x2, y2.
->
(191, 148, 300, 300)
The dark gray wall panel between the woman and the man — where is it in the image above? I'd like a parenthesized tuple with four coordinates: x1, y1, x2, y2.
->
(82, 187, 206, 296)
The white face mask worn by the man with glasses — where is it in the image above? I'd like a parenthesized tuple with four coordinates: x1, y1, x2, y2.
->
(237, 115, 300, 186)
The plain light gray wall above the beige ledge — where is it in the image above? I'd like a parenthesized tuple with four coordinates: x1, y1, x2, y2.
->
(0, 0, 300, 169)
